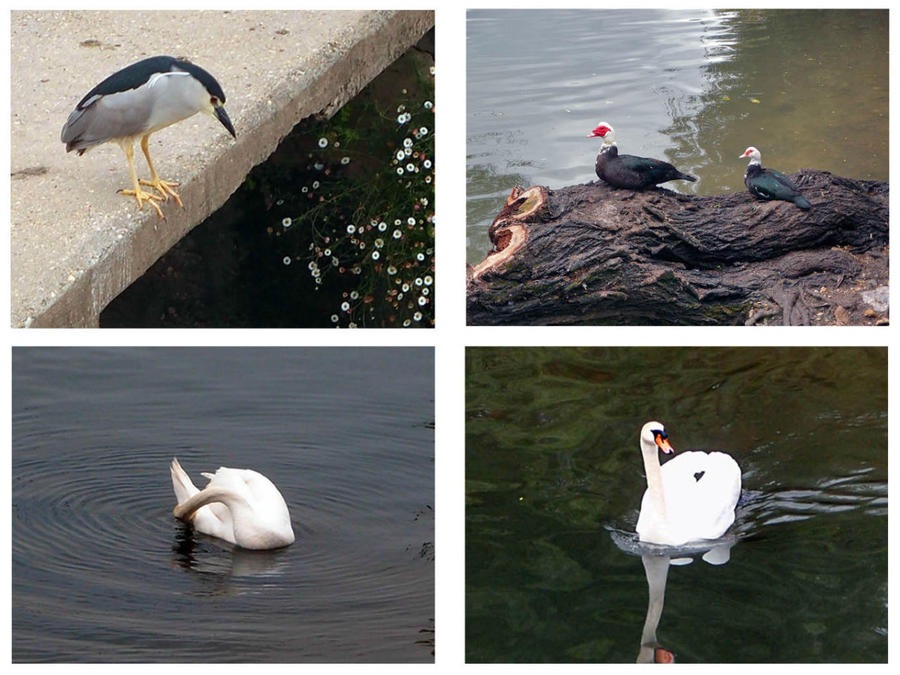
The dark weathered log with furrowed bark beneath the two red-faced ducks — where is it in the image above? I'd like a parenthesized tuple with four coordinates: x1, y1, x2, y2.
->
(467, 169, 889, 325)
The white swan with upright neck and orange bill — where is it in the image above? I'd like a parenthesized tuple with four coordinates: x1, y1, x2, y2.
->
(637, 422, 741, 546)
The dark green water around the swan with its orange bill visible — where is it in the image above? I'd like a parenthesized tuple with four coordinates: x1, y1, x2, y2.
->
(466, 348, 888, 662)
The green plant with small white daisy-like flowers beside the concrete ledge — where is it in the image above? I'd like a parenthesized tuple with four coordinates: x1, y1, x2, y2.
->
(270, 66, 435, 327)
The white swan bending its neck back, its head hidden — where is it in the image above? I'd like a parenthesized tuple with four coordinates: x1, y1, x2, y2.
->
(170, 459, 294, 549)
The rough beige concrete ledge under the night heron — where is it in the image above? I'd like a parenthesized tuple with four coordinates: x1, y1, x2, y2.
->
(10, 11, 434, 327)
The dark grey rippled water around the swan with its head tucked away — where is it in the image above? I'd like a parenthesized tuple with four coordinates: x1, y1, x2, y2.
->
(12, 348, 434, 662)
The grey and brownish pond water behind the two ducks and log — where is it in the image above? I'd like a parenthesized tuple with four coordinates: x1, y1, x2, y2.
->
(466, 9, 889, 264)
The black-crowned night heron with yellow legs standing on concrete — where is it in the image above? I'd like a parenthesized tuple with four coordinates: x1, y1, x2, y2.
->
(60, 56, 237, 218)
